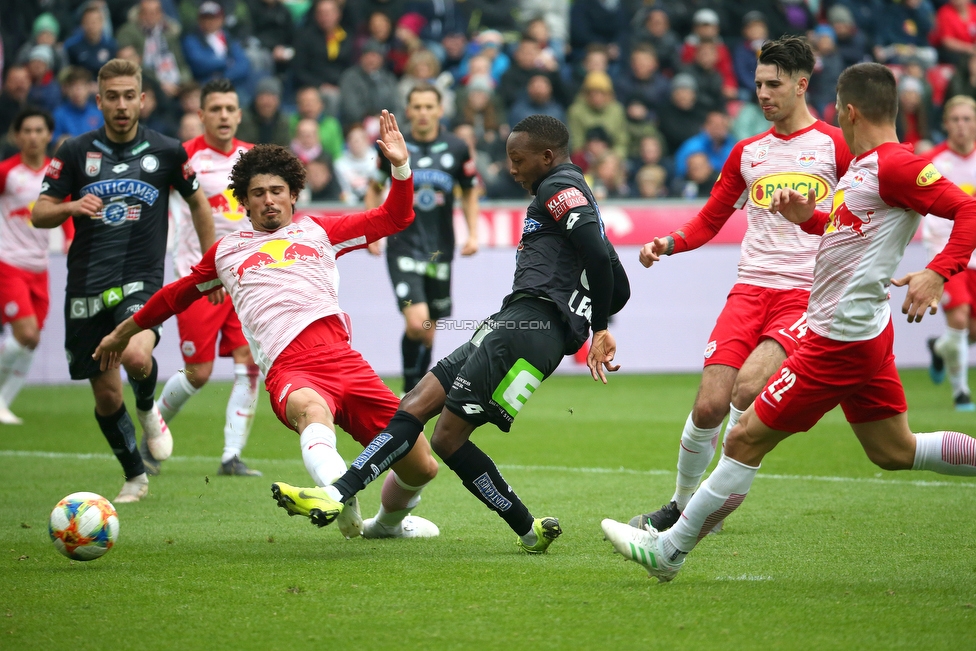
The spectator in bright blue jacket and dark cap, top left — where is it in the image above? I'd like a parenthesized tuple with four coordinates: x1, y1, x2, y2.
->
(183, 0, 254, 103)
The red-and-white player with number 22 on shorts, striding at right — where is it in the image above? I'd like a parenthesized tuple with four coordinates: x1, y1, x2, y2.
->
(603, 63, 976, 581)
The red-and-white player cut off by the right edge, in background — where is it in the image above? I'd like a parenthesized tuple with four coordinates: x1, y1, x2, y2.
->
(922, 95, 976, 411)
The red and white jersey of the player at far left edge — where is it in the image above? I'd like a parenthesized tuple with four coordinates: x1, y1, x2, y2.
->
(0, 154, 57, 273)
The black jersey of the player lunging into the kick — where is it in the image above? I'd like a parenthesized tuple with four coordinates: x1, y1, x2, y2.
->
(505, 163, 620, 355)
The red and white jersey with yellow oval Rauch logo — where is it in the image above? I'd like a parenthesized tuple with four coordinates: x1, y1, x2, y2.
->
(711, 120, 852, 289)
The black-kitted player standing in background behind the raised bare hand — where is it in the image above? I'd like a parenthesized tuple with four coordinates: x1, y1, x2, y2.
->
(366, 84, 478, 392)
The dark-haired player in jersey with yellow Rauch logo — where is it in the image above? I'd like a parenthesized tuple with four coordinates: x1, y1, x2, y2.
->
(632, 37, 851, 530)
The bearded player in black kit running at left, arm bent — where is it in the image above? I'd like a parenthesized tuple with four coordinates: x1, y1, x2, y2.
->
(31, 59, 214, 502)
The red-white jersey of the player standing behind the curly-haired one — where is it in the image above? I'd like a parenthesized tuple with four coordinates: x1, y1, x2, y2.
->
(170, 136, 254, 278)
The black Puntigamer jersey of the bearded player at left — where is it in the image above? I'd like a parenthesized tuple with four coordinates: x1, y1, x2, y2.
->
(41, 126, 199, 296)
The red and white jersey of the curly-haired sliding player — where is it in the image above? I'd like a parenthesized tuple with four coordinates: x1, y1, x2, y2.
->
(134, 176, 413, 375)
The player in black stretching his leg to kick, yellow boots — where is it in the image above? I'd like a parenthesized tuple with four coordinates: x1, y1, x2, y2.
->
(282, 115, 630, 554)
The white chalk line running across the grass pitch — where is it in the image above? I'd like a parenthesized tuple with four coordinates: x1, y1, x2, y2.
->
(0, 450, 976, 489)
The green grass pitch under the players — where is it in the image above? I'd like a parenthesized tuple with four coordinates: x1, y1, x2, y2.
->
(0, 371, 976, 651)
